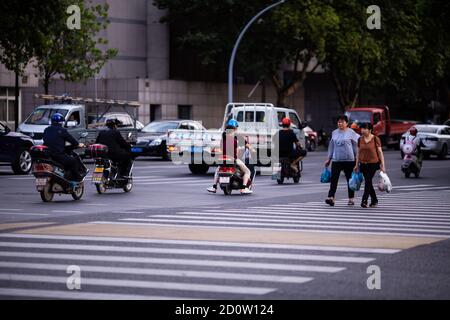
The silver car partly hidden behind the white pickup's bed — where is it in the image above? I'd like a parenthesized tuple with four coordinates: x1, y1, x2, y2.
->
(133, 119, 206, 160)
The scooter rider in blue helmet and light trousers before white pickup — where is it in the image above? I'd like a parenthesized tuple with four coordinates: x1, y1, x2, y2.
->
(206, 119, 253, 194)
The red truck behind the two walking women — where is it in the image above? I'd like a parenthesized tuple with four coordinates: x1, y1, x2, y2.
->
(345, 106, 416, 149)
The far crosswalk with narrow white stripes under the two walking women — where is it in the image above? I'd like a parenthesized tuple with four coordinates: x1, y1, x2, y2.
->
(100, 189, 450, 237)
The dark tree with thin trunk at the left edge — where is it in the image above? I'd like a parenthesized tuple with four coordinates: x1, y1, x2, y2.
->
(0, 0, 58, 128)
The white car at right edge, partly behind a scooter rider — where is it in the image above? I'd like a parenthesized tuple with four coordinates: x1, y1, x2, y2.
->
(400, 124, 450, 159)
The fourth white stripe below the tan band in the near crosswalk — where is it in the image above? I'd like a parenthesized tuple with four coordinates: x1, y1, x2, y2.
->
(0, 262, 314, 283)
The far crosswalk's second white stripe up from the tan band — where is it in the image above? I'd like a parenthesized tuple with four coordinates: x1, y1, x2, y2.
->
(127, 215, 450, 232)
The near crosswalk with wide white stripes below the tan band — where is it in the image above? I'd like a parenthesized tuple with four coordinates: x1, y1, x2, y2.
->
(0, 233, 399, 300)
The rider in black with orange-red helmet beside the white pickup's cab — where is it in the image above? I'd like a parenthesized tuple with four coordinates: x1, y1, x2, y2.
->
(274, 118, 306, 172)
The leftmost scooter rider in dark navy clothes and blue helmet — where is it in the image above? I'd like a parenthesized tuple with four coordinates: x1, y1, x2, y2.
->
(43, 113, 84, 181)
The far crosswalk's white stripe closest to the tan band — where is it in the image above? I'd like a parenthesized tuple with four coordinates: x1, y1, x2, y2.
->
(103, 219, 450, 236)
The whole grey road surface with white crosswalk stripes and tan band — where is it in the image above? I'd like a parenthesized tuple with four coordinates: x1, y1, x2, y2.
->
(0, 151, 450, 299)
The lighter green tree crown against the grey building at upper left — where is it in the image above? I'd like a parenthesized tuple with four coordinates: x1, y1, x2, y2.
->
(36, 0, 117, 94)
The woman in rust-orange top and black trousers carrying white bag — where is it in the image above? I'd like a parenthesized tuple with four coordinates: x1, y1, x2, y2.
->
(354, 123, 386, 208)
